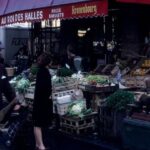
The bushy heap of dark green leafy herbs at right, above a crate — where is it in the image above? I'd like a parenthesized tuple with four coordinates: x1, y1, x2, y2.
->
(106, 90, 134, 111)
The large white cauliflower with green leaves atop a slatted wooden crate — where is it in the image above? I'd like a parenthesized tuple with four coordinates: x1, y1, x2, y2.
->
(67, 100, 92, 118)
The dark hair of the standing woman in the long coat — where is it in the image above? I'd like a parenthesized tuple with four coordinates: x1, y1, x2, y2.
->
(37, 53, 52, 67)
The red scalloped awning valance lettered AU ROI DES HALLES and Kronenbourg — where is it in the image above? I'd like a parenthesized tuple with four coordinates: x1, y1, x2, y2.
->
(0, 0, 108, 26)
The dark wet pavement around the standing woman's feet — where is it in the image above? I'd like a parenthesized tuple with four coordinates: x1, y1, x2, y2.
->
(0, 125, 121, 150)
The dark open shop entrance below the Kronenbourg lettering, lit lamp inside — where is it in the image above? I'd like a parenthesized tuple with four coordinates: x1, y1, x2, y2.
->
(61, 17, 105, 71)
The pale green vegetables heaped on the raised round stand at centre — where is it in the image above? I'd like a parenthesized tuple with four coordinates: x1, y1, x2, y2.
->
(86, 75, 109, 84)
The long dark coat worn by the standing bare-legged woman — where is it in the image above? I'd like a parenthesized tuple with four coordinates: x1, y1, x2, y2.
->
(33, 67, 53, 127)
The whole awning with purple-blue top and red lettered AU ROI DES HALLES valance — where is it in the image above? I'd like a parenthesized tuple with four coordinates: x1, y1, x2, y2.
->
(0, 0, 108, 25)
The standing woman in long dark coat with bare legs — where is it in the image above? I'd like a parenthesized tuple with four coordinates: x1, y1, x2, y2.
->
(33, 53, 52, 150)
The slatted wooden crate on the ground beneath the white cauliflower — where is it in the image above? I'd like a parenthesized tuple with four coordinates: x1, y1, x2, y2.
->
(60, 112, 97, 134)
